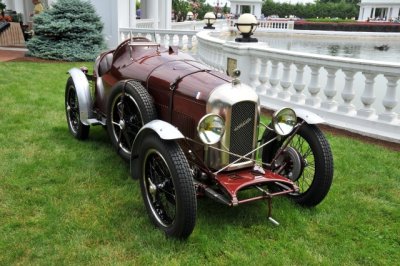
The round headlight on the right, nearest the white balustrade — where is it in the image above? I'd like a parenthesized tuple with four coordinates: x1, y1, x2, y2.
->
(272, 108, 297, 136)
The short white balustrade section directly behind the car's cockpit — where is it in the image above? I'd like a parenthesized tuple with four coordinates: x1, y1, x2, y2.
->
(119, 28, 197, 54)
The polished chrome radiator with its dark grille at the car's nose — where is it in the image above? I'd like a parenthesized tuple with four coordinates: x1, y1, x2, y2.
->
(205, 83, 260, 171)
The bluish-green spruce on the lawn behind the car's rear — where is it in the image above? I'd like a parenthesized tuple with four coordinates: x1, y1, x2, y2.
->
(27, 0, 105, 61)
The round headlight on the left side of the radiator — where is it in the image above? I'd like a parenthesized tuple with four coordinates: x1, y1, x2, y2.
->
(197, 114, 225, 145)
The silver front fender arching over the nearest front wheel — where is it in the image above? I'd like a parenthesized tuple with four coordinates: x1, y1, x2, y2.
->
(130, 120, 185, 179)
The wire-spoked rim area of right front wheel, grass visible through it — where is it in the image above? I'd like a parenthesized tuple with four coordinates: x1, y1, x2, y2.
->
(289, 135, 315, 194)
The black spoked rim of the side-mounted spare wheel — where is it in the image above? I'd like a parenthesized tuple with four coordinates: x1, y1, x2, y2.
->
(111, 94, 143, 153)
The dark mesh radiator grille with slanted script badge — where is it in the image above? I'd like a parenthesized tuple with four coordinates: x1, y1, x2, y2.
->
(229, 101, 256, 163)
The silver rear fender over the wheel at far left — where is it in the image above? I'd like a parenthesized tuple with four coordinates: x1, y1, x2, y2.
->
(68, 68, 93, 125)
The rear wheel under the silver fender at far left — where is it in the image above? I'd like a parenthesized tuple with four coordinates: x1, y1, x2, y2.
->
(65, 77, 90, 140)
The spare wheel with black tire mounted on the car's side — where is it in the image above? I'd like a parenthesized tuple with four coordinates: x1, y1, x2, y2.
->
(107, 81, 157, 161)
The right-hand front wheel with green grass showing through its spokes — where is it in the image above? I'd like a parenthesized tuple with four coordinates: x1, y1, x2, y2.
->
(262, 123, 333, 207)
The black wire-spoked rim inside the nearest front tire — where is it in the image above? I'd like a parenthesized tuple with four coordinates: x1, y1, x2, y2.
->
(143, 149, 176, 227)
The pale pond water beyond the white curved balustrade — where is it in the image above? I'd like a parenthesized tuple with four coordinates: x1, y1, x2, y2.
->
(218, 32, 400, 63)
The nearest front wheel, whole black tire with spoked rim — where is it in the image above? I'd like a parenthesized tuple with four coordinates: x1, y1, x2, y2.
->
(139, 135, 197, 239)
